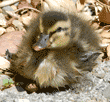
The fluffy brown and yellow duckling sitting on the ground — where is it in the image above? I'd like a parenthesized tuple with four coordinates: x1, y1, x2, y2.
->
(10, 11, 100, 91)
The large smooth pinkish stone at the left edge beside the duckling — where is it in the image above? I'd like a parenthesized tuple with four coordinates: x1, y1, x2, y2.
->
(0, 31, 25, 56)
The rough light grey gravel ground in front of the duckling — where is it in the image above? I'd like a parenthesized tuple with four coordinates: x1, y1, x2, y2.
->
(0, 61, 110, 102)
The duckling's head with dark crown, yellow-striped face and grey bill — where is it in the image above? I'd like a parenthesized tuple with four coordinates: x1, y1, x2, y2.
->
(33, 11, 71, 51)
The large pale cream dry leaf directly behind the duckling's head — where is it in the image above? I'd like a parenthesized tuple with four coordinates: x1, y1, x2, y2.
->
(41, 0, 77, 12)
